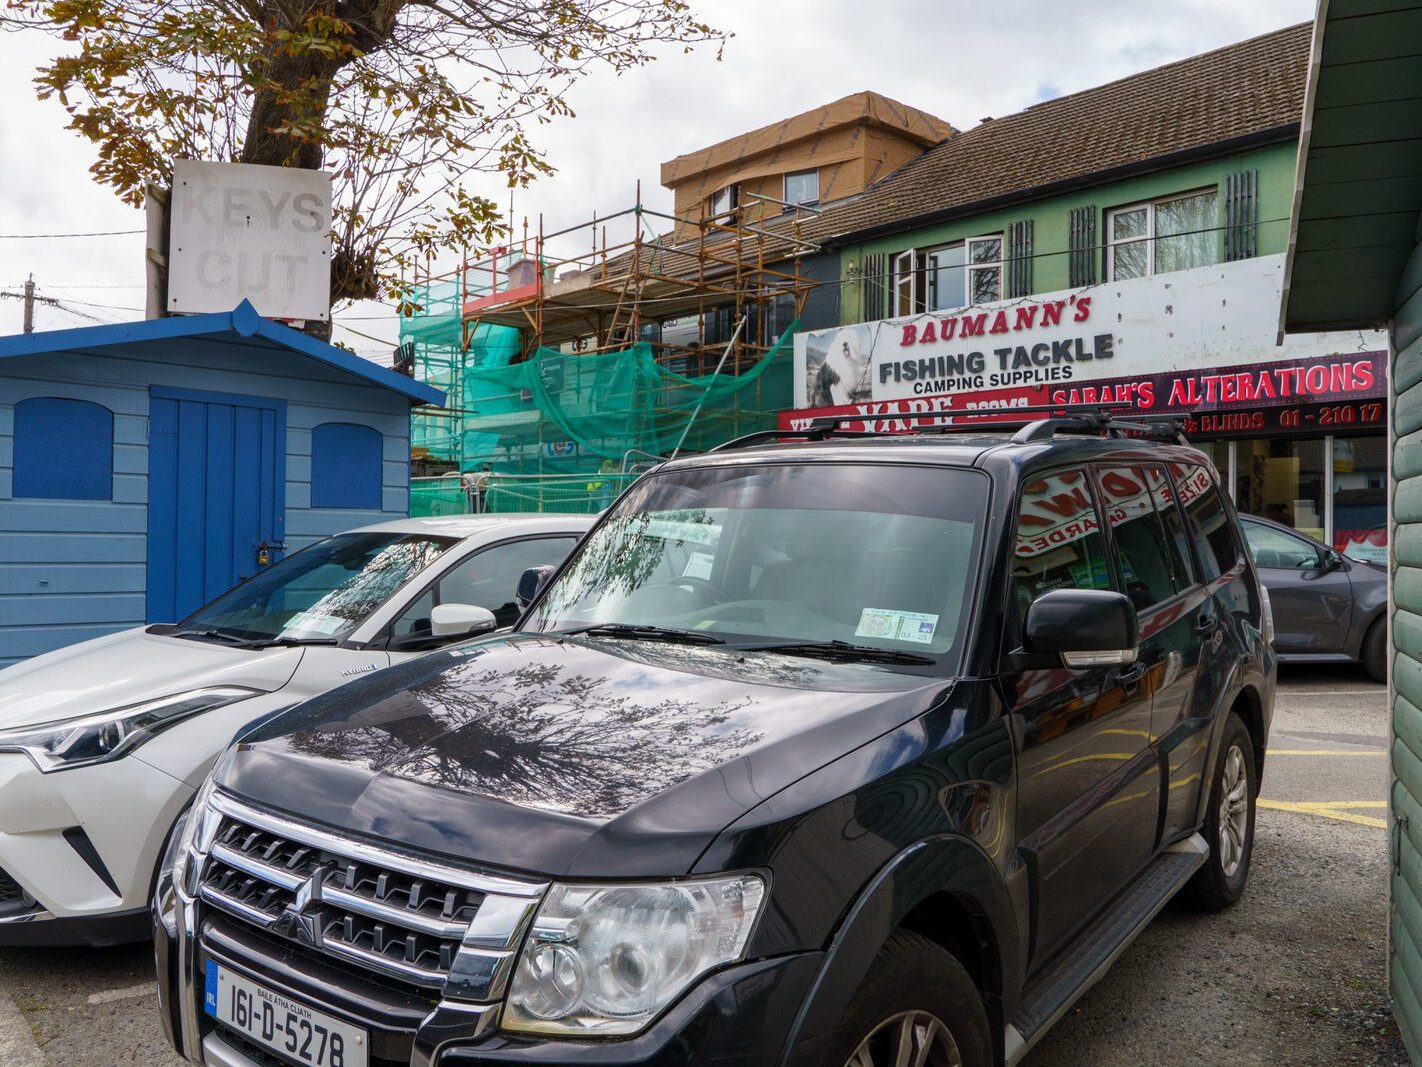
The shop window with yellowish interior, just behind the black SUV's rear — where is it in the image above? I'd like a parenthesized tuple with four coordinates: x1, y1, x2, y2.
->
(1234, 437, 1328, 541)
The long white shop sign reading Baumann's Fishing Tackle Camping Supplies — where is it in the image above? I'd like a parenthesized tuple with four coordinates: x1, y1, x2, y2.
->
(795, 256, 1386, 410)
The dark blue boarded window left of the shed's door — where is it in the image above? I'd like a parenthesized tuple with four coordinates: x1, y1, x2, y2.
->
(13, 397, 114, 501)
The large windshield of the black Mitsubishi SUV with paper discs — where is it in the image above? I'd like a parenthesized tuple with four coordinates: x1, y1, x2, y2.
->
(526, 464, 987, 664)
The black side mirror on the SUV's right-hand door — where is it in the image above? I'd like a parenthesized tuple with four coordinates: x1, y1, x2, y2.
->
(1024, 589, 1140, 669)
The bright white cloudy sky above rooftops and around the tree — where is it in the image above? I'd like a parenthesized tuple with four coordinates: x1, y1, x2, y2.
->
(0, 0, 1314, 363)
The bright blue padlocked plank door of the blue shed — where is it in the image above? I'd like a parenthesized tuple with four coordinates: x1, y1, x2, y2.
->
(148, 387, 286, 622)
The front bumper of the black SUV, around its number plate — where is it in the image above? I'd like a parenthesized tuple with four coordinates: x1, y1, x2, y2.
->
(154, 881, 822, 1067)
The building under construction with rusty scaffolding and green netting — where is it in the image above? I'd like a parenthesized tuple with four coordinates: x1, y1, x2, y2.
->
(401, 94, 947, 514)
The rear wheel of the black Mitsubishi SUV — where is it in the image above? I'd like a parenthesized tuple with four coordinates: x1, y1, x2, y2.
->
(1186, 711, 1258, 912)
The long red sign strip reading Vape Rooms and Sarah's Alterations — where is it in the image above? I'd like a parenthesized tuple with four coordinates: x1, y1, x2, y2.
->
(781, 350, 1388, 437)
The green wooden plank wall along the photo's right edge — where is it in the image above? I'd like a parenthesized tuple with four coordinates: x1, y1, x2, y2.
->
(1389, 237, 1422, 1056)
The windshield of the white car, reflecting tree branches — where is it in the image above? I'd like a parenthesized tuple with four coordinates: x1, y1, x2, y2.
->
(176, 534, 458, 642)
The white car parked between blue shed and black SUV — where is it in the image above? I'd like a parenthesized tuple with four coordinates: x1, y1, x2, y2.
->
(0, 515, 593, 945)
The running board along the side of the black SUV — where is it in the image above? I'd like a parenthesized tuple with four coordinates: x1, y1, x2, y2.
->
(1004, 834, 1210, 1067)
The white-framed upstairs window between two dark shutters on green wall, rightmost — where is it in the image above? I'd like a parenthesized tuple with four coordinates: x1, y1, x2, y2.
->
(1106, 189, 1219, 282)
